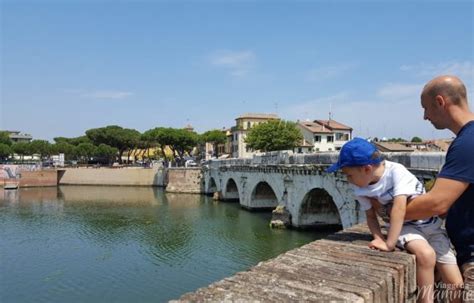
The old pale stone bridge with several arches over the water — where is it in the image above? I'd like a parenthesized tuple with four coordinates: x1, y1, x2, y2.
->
(203, 152, 444, 228)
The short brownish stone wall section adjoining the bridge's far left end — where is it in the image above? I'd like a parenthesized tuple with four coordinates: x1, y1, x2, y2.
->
(166, 167, 204, 194)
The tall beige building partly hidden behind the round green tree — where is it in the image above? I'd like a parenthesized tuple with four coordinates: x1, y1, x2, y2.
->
(231, 113, 280, 158)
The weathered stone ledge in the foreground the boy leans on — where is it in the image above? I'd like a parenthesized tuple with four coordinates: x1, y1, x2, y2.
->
(172, 224, 416, 302)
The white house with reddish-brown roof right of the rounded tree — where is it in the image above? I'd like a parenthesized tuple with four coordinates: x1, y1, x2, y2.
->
(296, 120, 352, 152)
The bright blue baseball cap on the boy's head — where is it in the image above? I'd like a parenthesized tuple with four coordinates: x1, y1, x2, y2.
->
(326, 138, 382, 173)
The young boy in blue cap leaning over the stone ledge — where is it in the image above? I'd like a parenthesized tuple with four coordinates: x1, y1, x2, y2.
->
(327, 138, 463, 302)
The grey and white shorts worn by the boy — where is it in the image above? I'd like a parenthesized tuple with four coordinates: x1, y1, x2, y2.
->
(397, 217, 457, 265)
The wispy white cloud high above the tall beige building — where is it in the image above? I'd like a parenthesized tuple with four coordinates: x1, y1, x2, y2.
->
(210, 50, 256, 77)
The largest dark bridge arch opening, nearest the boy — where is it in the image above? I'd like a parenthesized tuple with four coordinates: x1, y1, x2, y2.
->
(298, 187, 343, 227)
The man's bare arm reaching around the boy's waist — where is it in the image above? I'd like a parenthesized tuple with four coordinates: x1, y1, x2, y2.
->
(405, 178, 469, 220)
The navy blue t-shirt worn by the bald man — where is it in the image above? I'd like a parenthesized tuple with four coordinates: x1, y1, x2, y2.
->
(438, 121, 474, 265)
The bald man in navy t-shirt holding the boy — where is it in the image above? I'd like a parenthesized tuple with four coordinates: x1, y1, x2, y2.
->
(405, 76, 474, 302)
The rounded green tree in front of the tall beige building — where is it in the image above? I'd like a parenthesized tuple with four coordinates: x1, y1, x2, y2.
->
(245, 120, 303, 152)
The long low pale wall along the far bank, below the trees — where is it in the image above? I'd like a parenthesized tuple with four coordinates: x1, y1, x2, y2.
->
(59, 168, 166, 186)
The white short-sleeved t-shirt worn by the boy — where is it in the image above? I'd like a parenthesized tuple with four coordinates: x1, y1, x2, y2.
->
(354, 160, 426, 223)
